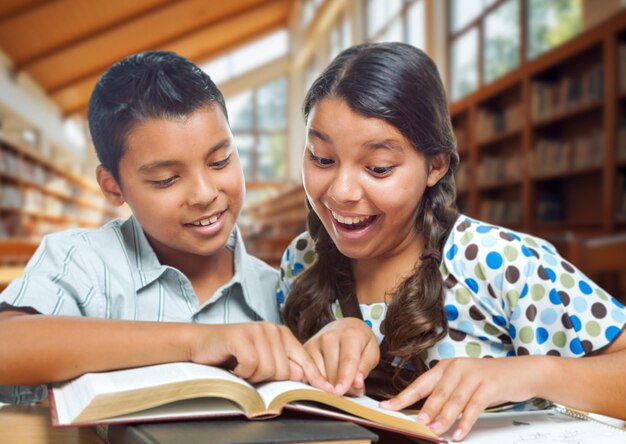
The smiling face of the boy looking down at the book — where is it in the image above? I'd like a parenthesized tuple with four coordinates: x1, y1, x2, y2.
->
(101, 106, 245, 265)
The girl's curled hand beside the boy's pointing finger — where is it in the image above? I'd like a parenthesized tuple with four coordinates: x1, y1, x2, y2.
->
(304, 318, 380, 395)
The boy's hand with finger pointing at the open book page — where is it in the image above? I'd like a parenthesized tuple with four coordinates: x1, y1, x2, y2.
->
(189, 322, 333, 392)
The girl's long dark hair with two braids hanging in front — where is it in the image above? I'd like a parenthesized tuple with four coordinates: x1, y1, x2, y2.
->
(282, 43, 459, 380)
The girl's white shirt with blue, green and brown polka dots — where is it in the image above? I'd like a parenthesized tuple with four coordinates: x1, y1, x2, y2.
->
(277, 216, 626, 367)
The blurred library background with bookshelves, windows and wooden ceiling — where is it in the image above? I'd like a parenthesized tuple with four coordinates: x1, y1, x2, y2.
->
(0, 0, 626, 294)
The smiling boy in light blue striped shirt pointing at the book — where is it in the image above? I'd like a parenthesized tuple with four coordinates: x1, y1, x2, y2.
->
(0, 51, 332, 403)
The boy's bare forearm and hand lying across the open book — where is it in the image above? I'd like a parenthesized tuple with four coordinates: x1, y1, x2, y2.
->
(0, 310, 332, 391)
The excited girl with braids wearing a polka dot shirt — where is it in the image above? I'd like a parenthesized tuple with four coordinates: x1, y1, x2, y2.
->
(278, 43, 626, 440)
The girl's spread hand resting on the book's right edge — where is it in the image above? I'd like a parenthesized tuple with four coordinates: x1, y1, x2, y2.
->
(381, 356, 546, 441)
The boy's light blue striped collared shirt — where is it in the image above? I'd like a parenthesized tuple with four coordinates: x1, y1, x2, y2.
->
(0, 216, 280, 403)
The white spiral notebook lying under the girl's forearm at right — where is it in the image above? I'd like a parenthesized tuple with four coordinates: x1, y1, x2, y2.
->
(448, 405, 626, 444)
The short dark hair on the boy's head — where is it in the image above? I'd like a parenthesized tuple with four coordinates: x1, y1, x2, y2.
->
(87, 51, 228, 184)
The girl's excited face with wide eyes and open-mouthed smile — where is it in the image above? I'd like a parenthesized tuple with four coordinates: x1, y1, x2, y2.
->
(303, 98, 447, 259)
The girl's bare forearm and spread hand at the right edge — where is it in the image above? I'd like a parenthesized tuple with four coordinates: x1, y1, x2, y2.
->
(381, 334, 626, 440)
